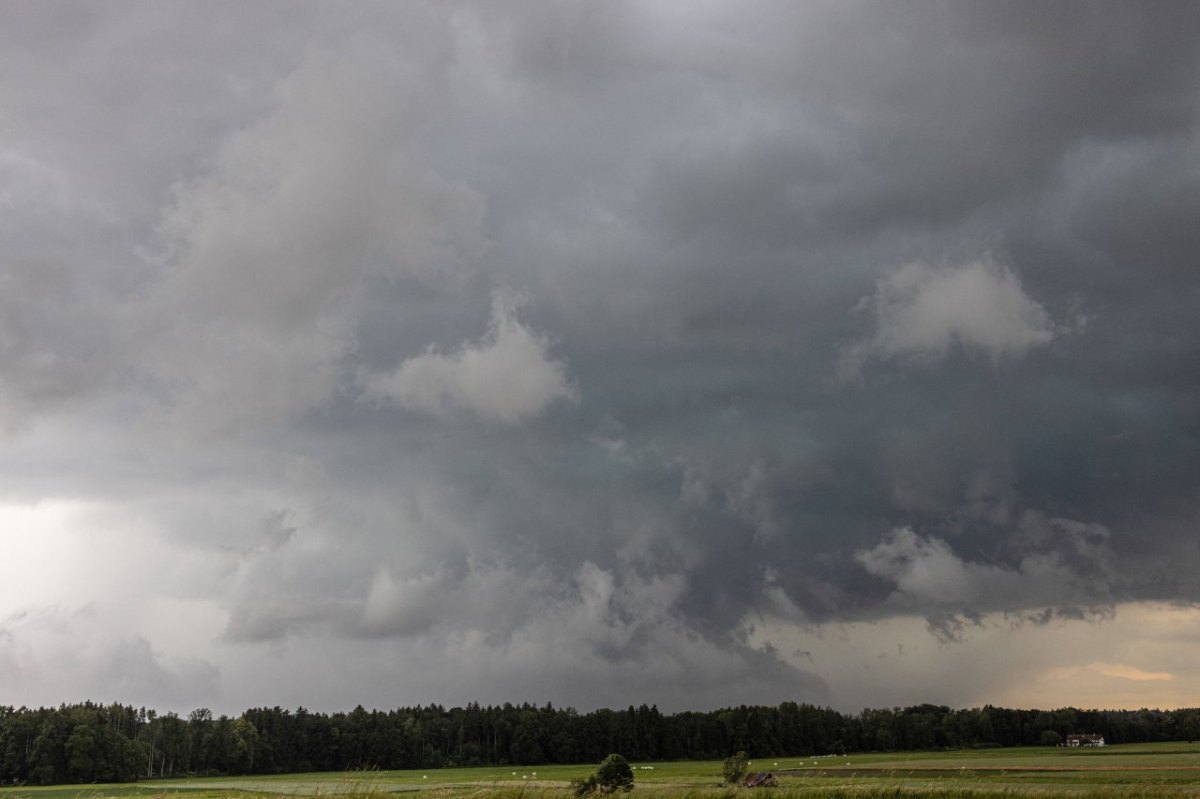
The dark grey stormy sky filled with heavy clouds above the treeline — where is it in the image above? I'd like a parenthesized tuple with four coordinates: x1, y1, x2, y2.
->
(0, 0, 1200, 714)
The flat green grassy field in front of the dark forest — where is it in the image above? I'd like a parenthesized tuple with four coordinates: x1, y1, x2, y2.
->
(7, 744, 1200, 799)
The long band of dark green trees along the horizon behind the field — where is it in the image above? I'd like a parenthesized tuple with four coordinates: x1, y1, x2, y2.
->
(0, 702, 1200, 785)
